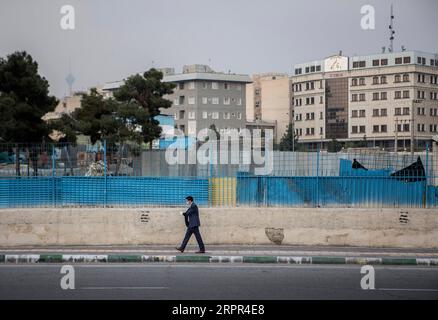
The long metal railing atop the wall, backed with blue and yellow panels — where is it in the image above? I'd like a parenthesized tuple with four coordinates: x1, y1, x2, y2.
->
(0, 142, 438, 208)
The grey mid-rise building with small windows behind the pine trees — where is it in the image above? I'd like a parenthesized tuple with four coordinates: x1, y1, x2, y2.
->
(104, 64, 251, 136)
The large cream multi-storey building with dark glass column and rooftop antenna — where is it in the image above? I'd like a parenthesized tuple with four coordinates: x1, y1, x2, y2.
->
(292, 51, 438, 150)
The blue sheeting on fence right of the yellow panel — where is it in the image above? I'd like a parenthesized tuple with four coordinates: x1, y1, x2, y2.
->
(237, 176, 438, 208)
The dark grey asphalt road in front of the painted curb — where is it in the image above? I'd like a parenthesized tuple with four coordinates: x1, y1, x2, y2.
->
(0, 263, 438, 300)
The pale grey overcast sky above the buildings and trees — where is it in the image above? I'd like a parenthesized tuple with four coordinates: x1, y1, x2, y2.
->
(0, 0, 438, 97)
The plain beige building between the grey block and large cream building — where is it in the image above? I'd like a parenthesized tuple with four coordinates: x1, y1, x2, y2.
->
(246, 73, 292, 143)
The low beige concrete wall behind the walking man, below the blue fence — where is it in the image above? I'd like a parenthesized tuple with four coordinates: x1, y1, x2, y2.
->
(0, 208, 438, 248)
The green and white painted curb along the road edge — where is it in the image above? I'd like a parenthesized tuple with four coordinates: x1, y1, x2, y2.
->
(0, 254, 438, 266)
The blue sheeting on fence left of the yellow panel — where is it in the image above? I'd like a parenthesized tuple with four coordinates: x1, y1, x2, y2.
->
(0, 177, 209, 208)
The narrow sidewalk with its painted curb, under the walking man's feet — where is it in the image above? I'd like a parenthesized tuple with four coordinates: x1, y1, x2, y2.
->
(0, 245, 438, 266)
